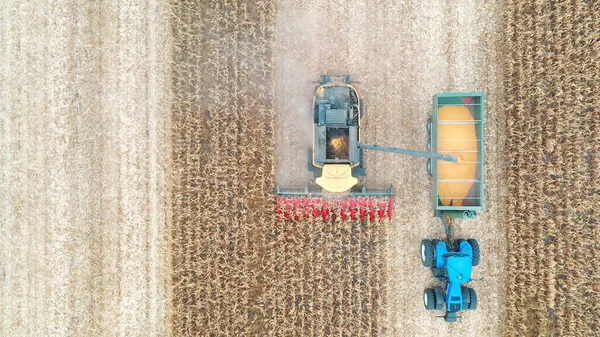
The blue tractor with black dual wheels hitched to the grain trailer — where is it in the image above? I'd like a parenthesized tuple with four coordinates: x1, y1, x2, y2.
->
(421, 218, 479, 322)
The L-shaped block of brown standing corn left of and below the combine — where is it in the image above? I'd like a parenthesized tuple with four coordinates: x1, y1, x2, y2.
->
(171, 1, 387, 336)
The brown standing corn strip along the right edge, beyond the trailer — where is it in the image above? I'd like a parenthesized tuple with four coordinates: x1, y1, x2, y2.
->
(505, 1, 600, 336)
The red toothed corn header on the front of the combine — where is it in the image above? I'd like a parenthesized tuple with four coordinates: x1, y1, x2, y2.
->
(276, 197, 394, 221)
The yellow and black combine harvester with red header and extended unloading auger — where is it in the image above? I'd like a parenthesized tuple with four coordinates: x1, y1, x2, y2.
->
(277, 75, 466, 221)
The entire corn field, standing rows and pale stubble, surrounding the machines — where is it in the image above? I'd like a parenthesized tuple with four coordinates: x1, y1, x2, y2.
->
(0, 0, 600, 336)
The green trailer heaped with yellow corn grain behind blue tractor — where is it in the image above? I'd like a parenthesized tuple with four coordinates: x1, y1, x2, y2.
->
(428, 92, 485, 217)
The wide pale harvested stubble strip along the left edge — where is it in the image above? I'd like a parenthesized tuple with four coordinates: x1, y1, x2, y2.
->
(0, 1, 169, 336)
